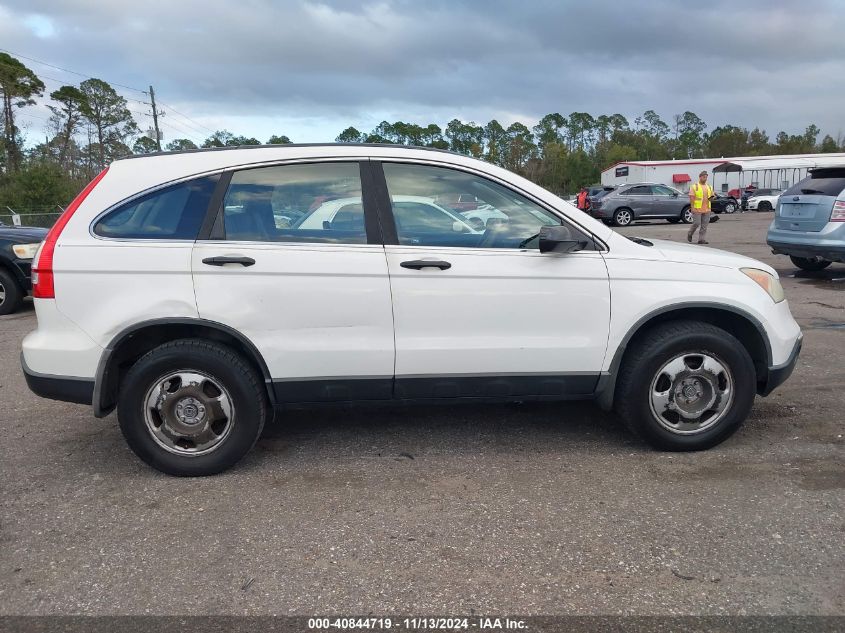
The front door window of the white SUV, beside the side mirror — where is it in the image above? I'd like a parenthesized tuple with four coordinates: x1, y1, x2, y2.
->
(383, 163, 576, 249)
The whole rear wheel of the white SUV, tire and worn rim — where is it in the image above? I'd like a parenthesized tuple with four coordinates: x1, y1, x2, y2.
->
(118, 339, 268, 476)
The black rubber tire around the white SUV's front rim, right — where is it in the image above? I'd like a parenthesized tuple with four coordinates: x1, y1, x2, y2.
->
(614, 321, 757, 451)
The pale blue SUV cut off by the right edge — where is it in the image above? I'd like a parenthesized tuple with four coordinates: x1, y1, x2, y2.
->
(766, 166, 845, 270)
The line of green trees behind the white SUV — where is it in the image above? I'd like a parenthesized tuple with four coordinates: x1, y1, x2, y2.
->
(0, 53, 845, 213)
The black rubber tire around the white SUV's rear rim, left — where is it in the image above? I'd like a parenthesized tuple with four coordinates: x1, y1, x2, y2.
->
(117, 339, 268, 477)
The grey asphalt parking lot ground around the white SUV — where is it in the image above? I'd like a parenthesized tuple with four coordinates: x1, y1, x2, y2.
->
(0, 213, 845, 615)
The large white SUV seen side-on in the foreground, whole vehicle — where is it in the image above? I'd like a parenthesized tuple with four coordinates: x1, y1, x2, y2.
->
(22, 145, 801, 475)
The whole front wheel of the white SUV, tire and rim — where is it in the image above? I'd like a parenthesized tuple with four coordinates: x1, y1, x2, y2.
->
(615, 321, 757, 451)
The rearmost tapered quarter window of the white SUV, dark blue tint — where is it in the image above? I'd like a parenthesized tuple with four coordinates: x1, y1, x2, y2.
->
(94, 175, 219, 240)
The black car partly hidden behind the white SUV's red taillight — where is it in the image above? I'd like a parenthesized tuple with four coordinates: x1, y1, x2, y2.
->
(0, 222, 47, 315)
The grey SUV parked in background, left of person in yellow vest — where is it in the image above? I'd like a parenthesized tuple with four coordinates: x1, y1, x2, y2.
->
(588, 182, 692, 226)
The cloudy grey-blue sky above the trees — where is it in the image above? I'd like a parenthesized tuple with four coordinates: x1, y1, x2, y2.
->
(0, 0, 845, 142)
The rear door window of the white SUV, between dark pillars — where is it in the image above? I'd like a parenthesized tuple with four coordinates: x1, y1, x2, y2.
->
(223, 163, 367, 244)
